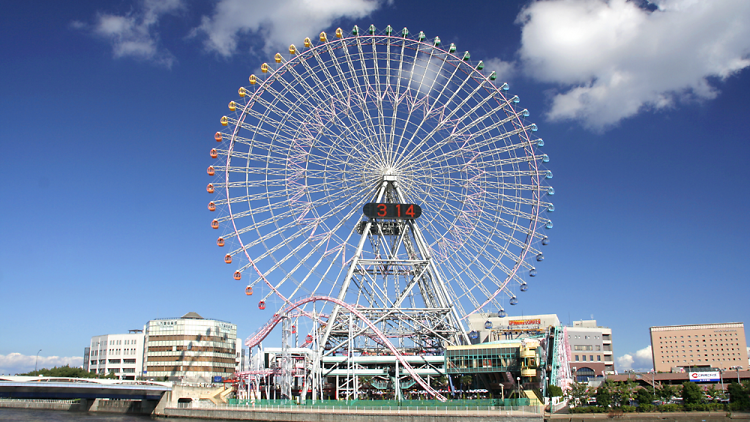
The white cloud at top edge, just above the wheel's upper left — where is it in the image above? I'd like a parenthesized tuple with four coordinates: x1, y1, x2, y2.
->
(193, 0, 382, 57)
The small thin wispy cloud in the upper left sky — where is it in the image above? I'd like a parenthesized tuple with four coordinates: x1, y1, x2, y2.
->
(76, 0, 184, 68)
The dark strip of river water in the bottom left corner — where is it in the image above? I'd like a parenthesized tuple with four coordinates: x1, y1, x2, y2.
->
(0, 408, 217, 422)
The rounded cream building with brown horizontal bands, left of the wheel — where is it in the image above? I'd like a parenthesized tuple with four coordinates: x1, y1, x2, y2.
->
(143, 312, 241, 382)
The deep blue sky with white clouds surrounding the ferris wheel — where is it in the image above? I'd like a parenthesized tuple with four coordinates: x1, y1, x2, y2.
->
(0, 0, 750, 373)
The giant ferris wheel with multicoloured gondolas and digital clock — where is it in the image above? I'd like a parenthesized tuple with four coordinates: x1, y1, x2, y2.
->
(207, 26, 554, 342)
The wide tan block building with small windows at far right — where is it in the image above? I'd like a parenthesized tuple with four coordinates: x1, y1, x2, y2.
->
(650, 322, 748, 372)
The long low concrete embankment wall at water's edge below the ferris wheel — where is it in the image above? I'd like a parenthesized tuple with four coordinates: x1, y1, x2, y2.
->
(163, 408, 543, 422)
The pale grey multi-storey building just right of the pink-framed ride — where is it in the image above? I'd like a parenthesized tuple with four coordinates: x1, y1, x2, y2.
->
(567, 319, 615, 382)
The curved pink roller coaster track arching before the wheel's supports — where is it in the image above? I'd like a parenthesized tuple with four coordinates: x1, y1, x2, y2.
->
(245, 296, 447, 401)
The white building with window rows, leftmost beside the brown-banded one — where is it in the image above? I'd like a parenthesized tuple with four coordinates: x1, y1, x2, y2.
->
(83, 330, 143, 380)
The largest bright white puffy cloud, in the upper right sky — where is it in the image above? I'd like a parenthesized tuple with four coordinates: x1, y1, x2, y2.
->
(518, 0, 750, 130)
